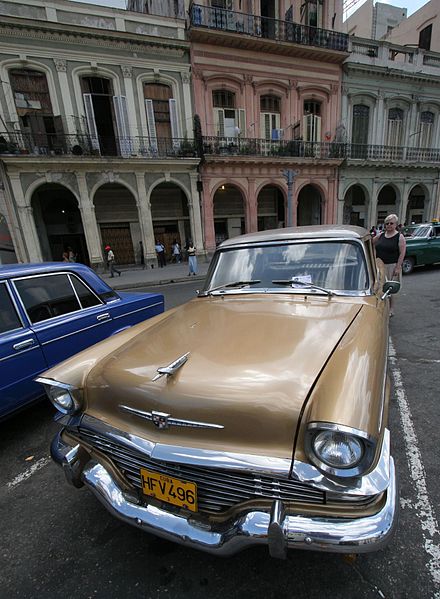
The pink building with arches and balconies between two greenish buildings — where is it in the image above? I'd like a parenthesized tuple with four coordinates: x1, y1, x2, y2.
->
(189, 0, 348, 252)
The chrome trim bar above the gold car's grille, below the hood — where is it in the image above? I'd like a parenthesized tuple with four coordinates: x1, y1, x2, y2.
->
(66, 414, 391, 497)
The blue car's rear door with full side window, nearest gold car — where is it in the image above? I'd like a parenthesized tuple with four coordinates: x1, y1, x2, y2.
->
(14, 273, 113, 367)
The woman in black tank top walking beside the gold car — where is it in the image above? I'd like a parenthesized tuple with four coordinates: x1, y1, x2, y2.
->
(373, 214, 406, 316)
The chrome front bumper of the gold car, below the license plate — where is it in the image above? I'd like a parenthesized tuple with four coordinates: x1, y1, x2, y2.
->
(51, 435, 397, 558)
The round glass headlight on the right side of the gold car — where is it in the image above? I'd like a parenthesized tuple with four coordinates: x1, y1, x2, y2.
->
(313, 430, 364, 468)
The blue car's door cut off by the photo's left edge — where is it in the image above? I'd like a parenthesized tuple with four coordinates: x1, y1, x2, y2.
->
(0, 281, 47, 417)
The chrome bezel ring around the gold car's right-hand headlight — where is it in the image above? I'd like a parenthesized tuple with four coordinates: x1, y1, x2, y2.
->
(304, 422, 376, 478)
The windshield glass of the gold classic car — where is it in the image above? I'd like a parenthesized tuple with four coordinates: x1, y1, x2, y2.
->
(203, 240, 369, 291)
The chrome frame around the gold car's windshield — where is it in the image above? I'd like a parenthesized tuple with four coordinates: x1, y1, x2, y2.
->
(202, 237, 375, 297)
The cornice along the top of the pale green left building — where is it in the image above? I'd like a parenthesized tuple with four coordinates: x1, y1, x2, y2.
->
(0, 17, 189, 57)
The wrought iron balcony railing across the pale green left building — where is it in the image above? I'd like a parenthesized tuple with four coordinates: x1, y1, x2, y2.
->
(0, 133, 197, 159)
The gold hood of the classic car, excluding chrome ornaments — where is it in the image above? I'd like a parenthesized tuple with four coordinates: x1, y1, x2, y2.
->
(85, 294, 361, 457)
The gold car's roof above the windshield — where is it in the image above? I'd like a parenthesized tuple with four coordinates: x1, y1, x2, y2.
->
(219, 225, 370, 249)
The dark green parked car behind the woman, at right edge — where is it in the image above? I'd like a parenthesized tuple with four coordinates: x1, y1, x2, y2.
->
(402, 221, 440, 275)
